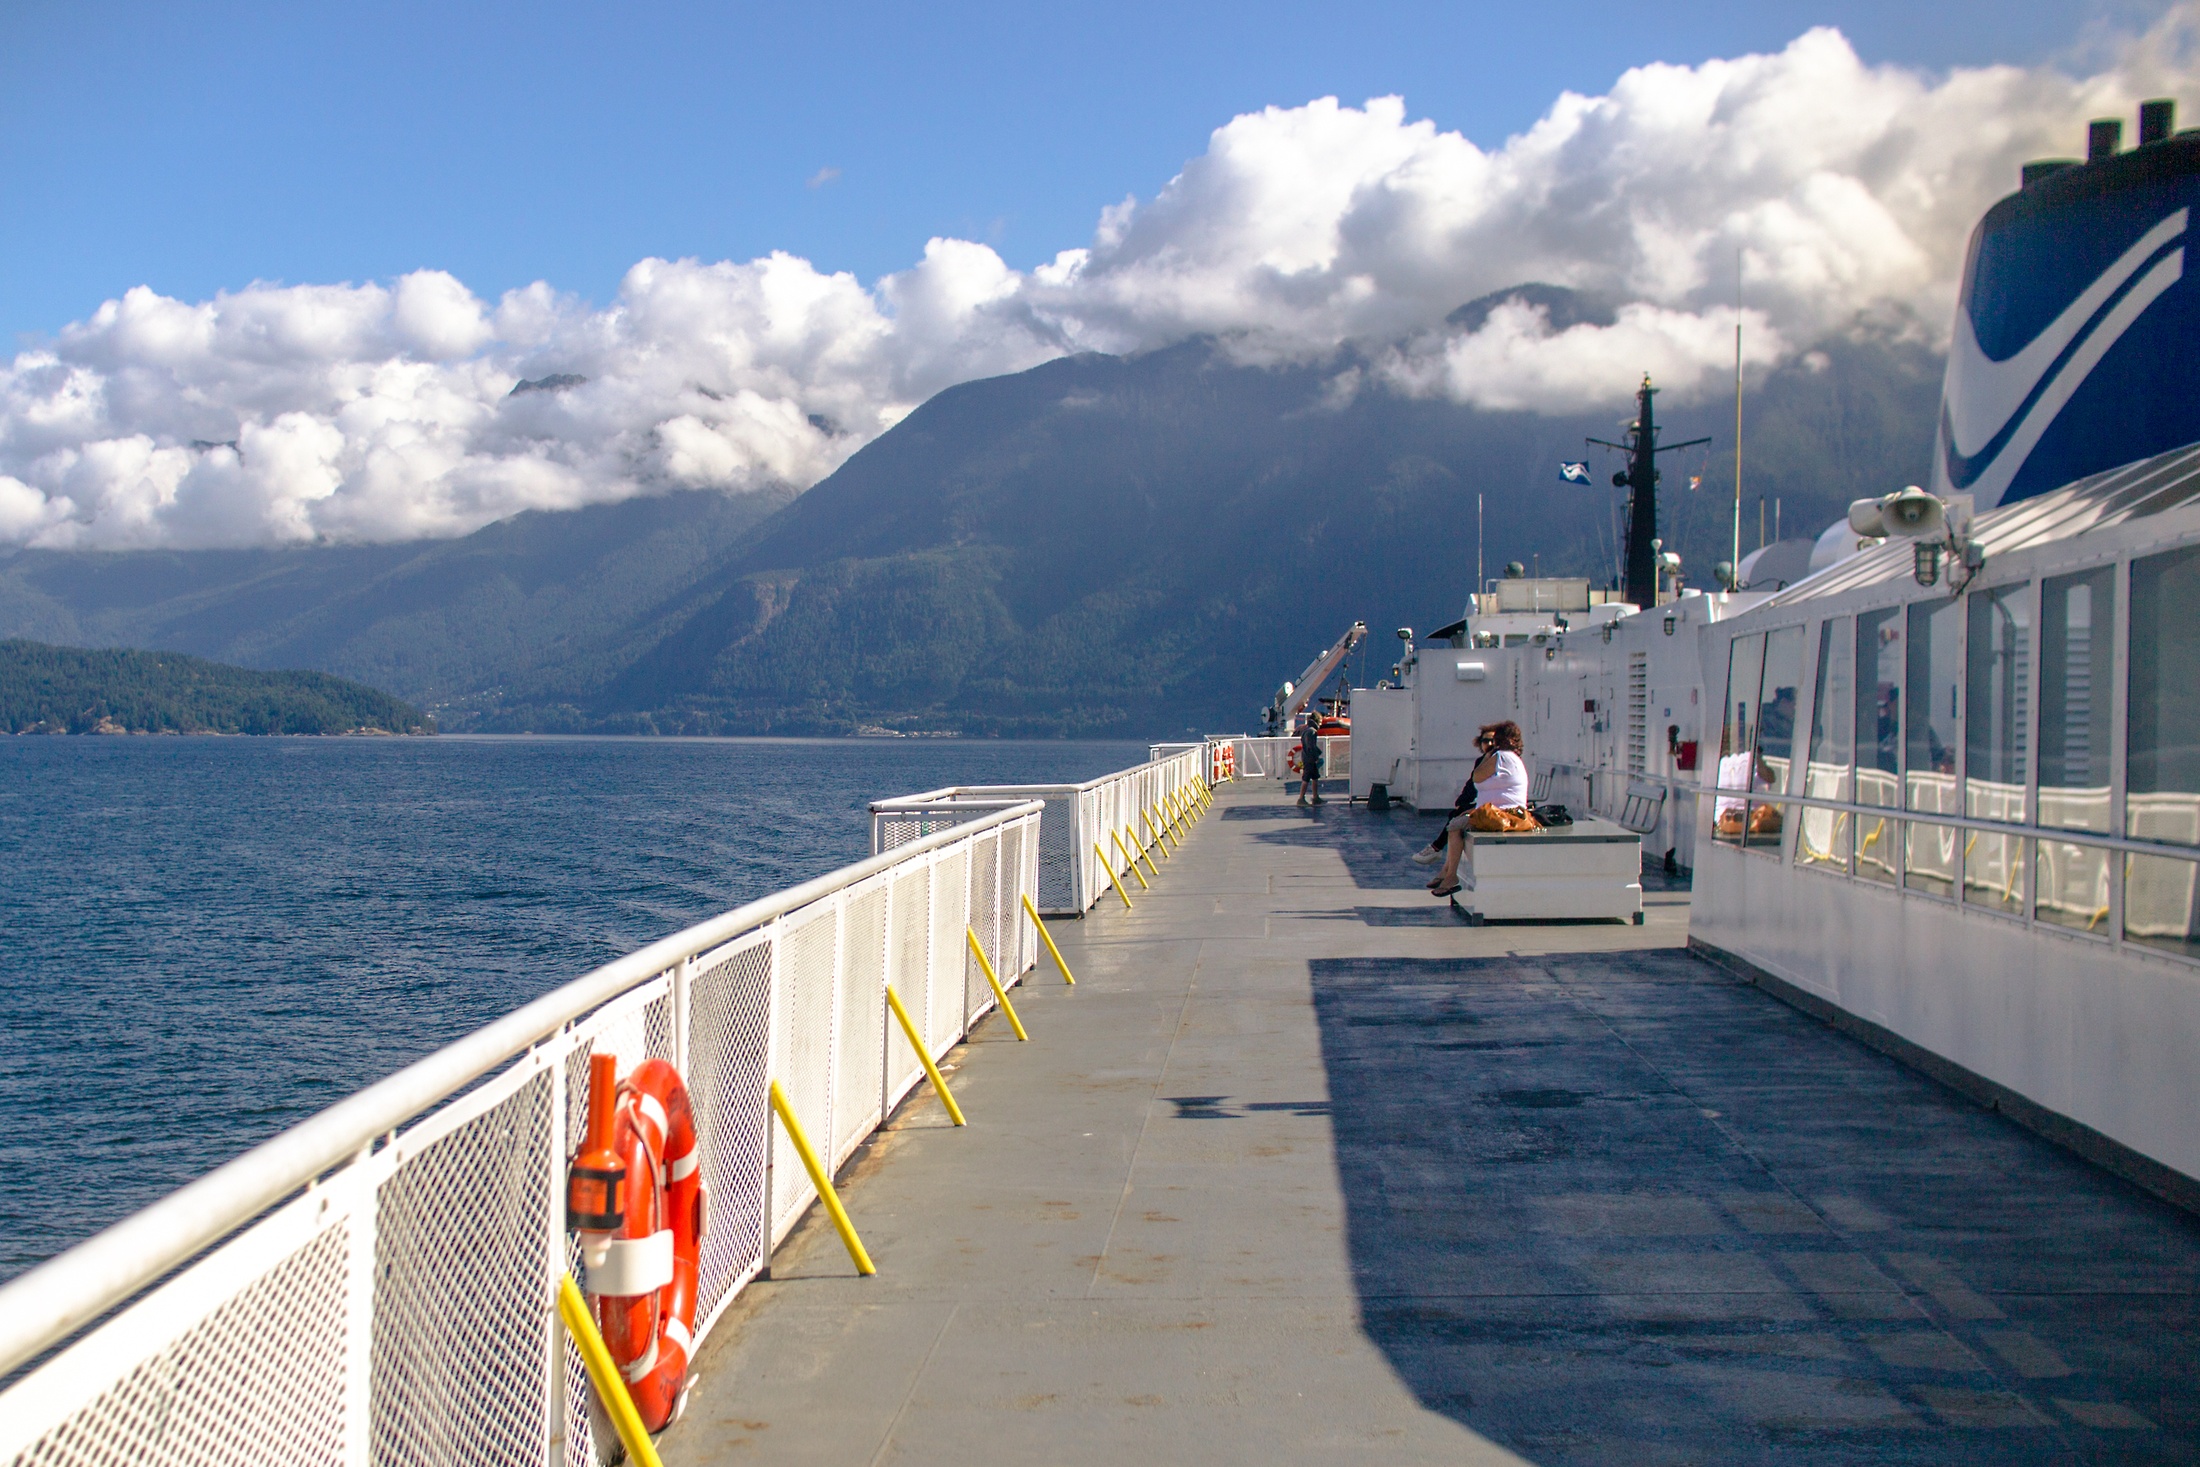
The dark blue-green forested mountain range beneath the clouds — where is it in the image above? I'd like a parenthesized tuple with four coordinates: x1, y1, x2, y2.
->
(0, 286, 1940, 737)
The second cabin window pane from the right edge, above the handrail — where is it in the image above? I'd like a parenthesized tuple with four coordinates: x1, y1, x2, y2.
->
(2039, 565, 2116, 834)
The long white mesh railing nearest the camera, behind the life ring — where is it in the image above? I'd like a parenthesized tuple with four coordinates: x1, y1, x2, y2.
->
(0, 804, 1047, 1467)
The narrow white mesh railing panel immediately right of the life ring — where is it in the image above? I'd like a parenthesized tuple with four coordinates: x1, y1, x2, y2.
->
(689, 933, 772, 1324)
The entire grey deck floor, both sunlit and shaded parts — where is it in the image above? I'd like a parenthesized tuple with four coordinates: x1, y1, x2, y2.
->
(662, 785, 2200, 1465)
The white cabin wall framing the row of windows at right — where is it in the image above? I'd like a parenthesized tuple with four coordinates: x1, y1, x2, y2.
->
(1690, 453, 2200, 1177)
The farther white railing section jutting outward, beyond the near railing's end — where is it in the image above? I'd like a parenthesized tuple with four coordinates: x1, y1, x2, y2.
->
(871, 743, 1206, 917)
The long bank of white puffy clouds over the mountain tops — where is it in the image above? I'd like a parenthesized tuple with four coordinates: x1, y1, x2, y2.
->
(0, 9, 2200, 548)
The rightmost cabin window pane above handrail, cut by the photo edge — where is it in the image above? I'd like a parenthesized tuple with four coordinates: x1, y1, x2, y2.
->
(2123, 545, 2200, 845)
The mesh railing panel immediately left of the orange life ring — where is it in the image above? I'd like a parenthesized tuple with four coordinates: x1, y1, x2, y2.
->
(370, 1071, 554, 1467)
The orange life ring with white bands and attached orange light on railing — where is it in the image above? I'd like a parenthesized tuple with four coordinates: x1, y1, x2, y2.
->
(568, 1056, 704, 1432)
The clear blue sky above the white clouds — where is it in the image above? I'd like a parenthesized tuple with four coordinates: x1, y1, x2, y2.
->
(0, 0, 2160, 339)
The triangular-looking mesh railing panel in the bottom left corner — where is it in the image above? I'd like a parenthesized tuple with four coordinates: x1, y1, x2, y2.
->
(9, 1227, 350, 1467)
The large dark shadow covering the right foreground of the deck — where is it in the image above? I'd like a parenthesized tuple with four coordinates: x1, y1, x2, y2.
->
(1278, 945, 2200, 1463)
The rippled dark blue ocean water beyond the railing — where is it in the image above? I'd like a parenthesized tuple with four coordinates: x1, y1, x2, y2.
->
(0, 737, 1146, 1278)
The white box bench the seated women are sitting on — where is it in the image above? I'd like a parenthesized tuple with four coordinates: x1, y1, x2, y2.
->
(1452, 818, 1643, 926)
